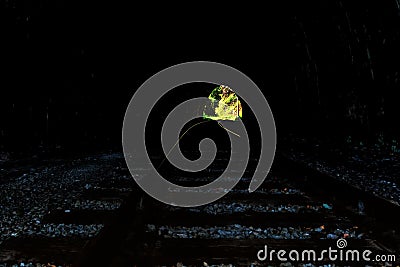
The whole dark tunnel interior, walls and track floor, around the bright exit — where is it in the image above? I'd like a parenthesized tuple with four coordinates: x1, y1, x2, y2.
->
(0, 0, 400, 267)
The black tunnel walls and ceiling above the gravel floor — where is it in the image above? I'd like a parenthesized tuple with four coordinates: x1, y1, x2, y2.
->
(0, 0, 400, 155)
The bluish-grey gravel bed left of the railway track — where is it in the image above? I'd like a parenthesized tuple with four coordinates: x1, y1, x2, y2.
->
(0, 154, 133, 266)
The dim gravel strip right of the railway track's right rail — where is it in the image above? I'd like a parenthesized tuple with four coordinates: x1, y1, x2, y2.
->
(285, 137, 400, 205)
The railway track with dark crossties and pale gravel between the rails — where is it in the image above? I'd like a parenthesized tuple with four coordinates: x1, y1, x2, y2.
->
(79, 156, 398, 266)
